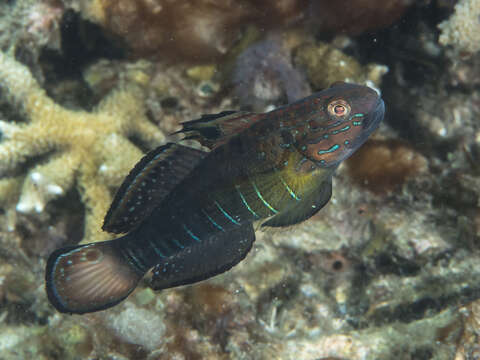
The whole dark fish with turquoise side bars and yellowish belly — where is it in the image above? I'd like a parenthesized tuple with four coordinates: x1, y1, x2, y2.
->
(46, 83, 384, 314)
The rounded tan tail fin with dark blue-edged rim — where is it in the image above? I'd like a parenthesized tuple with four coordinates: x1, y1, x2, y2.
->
(45, 239, 144, 314)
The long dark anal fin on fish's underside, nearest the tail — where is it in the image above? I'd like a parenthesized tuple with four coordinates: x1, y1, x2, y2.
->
(151, 224, 255, 290)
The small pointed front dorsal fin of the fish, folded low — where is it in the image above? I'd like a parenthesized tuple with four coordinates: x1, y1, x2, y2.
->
(175, 111, 262, 149)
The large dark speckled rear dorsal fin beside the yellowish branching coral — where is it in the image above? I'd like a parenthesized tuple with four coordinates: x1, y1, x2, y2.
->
(102, 143, 207, 234)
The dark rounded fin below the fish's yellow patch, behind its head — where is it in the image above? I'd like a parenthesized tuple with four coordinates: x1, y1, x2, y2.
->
(262, 177, 332, 227)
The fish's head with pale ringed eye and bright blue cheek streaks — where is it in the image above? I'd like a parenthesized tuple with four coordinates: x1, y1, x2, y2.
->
(296, 82, 385, 168)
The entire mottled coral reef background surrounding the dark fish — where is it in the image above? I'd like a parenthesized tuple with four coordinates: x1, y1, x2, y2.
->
(0, 0, 480, 360)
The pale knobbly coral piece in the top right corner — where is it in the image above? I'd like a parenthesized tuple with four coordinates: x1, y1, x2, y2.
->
(438, 0, 480, 54)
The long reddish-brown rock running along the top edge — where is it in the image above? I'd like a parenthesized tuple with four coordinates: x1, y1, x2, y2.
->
(63, 0, 412, 63)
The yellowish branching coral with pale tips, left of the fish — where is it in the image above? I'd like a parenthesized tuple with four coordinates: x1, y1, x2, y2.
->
(0, 53, 164, 241)
